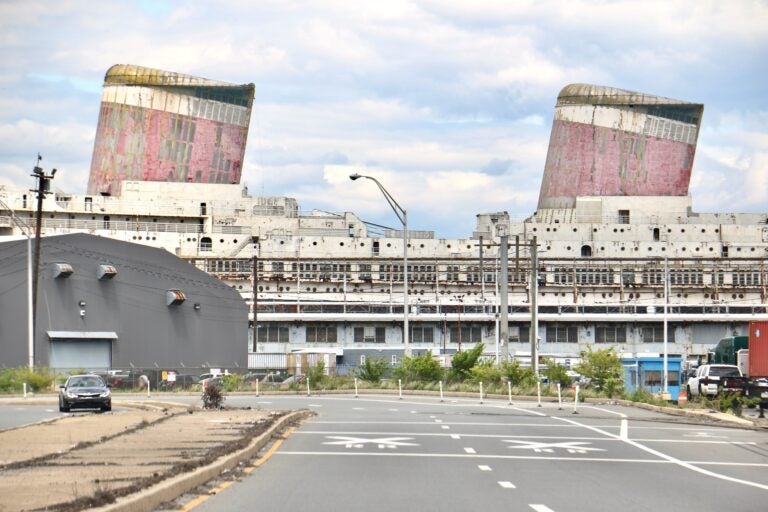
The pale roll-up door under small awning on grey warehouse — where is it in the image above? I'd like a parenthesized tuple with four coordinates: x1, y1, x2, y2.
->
(48, 331, 117, 370)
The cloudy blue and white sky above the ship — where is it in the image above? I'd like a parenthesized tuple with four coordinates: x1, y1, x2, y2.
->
(0, 0, 768, 238)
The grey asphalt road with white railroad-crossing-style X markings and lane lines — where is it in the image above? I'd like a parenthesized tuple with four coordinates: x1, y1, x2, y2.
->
(182, 396, 768, 512)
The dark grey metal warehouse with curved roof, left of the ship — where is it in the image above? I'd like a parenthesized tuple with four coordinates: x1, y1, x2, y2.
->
(0, 233, 248, 370)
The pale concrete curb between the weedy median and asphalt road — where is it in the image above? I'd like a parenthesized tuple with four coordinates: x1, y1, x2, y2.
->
(91, 411, 311, 512)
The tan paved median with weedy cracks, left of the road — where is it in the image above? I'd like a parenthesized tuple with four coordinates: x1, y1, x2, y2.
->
(0, 407, 304, 512)
